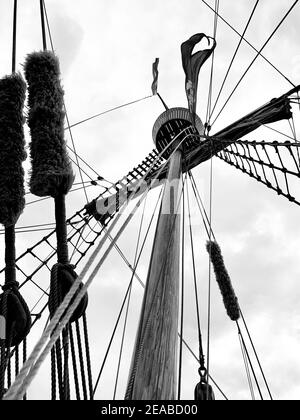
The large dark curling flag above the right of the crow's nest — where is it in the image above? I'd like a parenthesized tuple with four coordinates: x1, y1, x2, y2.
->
(181, 33, 217, 121)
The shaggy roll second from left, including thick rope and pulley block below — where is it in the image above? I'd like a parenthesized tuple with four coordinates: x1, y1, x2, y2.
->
(25, 51, 87, 321)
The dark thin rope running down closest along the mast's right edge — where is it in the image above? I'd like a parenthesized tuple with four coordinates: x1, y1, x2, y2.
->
(177, 174, 187, 401)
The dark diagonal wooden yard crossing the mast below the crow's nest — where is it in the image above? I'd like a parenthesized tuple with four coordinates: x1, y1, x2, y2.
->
(86, 86, 300, 222)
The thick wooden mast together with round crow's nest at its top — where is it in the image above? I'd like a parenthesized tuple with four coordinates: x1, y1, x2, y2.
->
(126, 108, 203, 400)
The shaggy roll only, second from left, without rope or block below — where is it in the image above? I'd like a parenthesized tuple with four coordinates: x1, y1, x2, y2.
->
(25, 51, 74, 197)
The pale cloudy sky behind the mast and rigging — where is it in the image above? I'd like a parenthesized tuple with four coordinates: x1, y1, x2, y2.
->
(0, 0, 300, 399)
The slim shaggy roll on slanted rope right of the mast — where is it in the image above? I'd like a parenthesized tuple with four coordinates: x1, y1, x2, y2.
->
(206, 241, 240, 321)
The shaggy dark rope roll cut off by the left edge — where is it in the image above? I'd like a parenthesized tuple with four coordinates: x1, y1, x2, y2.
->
(0, 73, 26, 227)
